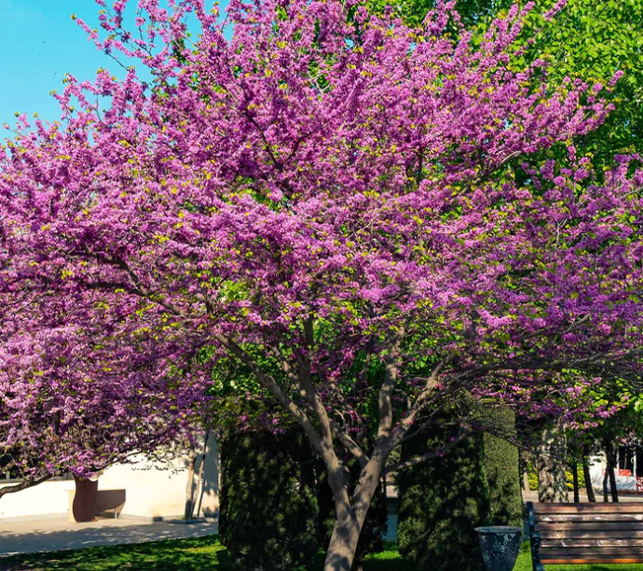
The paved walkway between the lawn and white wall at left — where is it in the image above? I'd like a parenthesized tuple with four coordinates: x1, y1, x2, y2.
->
(0, 519, 217, 557)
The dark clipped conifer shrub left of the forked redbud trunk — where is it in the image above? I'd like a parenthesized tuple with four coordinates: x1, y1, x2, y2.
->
(219, 430, 319, 571)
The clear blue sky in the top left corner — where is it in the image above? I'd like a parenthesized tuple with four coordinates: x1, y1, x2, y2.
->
(0, 0, 229, 139)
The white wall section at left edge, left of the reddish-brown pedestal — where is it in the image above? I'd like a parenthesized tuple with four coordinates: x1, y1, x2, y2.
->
(0, 480, 74, 519)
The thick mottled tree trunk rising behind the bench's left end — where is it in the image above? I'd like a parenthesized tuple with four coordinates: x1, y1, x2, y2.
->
(536, 426, 569, 503)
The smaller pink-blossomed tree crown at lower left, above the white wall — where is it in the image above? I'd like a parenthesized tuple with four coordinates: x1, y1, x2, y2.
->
(0, 306, 198, 498)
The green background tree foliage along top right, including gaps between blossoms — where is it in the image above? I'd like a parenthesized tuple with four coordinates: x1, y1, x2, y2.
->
(370, 0, 643, 168)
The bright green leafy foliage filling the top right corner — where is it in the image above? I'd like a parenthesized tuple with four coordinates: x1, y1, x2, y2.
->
(530, 0, 643, 168)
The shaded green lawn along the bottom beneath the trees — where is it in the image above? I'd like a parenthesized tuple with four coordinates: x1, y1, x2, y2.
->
(0, 536, 643, 571)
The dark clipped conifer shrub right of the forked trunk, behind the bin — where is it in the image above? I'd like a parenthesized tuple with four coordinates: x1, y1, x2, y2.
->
(397, 409, 522, 571)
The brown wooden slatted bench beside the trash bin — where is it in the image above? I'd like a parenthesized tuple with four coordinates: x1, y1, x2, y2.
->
(527, 502, 643, 571)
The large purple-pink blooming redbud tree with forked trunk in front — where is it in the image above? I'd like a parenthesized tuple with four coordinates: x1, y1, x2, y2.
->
(0, 0, 643, 571)
